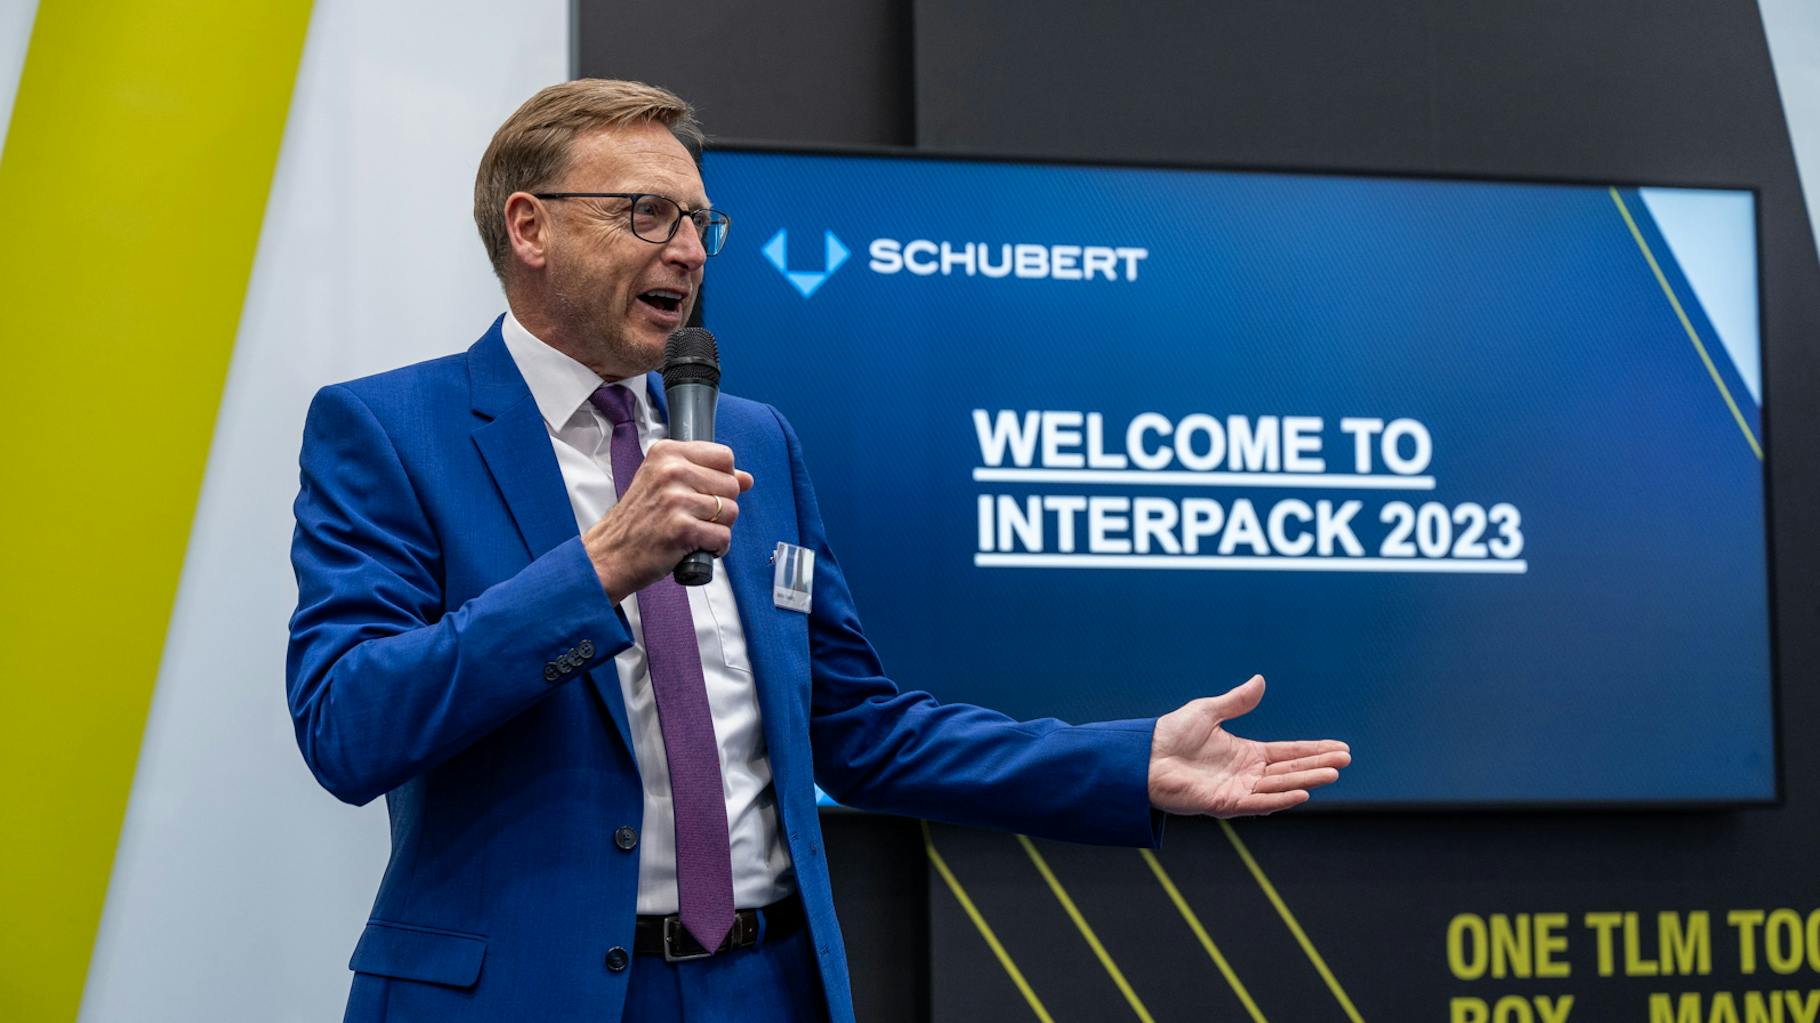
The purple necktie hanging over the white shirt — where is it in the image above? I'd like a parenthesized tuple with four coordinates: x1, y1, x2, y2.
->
(588, 386, 733, 950)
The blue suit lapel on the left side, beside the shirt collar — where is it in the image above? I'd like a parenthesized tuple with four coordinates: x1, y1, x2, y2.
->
(468, 317, 632, 752)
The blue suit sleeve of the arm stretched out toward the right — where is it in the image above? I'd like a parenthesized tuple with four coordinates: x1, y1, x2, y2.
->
(777, 405, 1163, 848)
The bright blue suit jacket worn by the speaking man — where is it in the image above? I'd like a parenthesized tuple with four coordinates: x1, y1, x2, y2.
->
(288, 314, 1156, 1023)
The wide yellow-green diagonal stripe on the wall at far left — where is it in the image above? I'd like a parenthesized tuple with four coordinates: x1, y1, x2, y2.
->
(0, 0, 309, 1021)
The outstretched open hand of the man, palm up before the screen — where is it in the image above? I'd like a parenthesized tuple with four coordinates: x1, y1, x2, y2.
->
(1150, 675, 1352, 817)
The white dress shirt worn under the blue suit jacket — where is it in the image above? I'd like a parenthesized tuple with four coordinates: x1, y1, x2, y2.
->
(501, 313, 794, 916)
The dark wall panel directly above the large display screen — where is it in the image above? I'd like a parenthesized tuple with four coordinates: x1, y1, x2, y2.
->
(915, 0, 1793, 184)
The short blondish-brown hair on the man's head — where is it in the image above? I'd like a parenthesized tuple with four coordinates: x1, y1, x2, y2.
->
(473, 78, 704, 280)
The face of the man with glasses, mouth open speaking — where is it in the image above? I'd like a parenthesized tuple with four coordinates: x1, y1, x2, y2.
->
(546, 124, 708, 379)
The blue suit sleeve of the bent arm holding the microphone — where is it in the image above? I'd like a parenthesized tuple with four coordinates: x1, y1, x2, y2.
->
(286, 386, 632, 805)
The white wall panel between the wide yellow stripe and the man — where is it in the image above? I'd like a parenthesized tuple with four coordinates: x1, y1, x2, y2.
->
(82, 0, 570, 1023)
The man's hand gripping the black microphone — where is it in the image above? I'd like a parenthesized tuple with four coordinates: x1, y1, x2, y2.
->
(581, 441, 752, 604)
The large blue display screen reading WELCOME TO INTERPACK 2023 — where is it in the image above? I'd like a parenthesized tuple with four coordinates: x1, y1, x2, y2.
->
(704, 149, 1776, 806)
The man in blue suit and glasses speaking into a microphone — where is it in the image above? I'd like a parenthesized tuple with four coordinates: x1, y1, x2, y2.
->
(288, 80, 1349, 1023)
